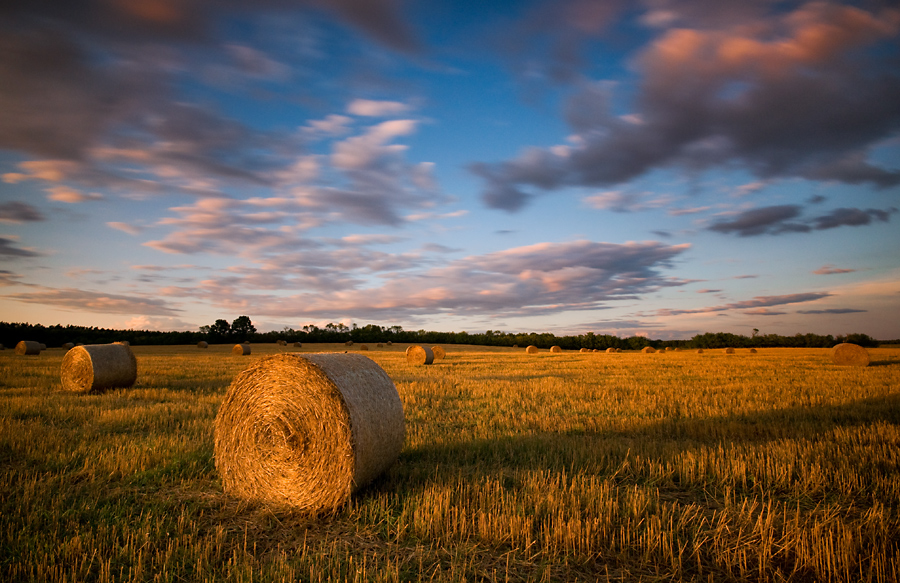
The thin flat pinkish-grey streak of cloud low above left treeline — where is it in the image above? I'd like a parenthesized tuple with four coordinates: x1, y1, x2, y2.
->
(3, 288, 181, 316)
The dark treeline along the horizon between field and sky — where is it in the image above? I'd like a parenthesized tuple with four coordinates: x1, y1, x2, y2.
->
(0, 316, 884, 350)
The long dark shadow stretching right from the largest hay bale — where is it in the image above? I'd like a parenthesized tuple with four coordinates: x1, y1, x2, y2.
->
(372, 394, 900, 490)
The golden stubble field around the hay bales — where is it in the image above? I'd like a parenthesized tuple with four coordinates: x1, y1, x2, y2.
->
(0, 345, 900, 583)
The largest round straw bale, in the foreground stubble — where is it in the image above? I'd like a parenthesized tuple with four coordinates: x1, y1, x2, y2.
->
(215, 353, 405, 514)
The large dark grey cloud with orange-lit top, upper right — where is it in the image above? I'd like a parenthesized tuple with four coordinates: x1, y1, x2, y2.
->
(470, 1, 900, 212)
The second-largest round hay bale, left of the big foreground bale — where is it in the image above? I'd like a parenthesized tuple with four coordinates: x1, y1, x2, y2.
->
(60, 342, 137, 393)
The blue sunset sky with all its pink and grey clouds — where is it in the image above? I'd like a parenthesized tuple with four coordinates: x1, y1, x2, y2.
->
(0, 0, 900, 339)
